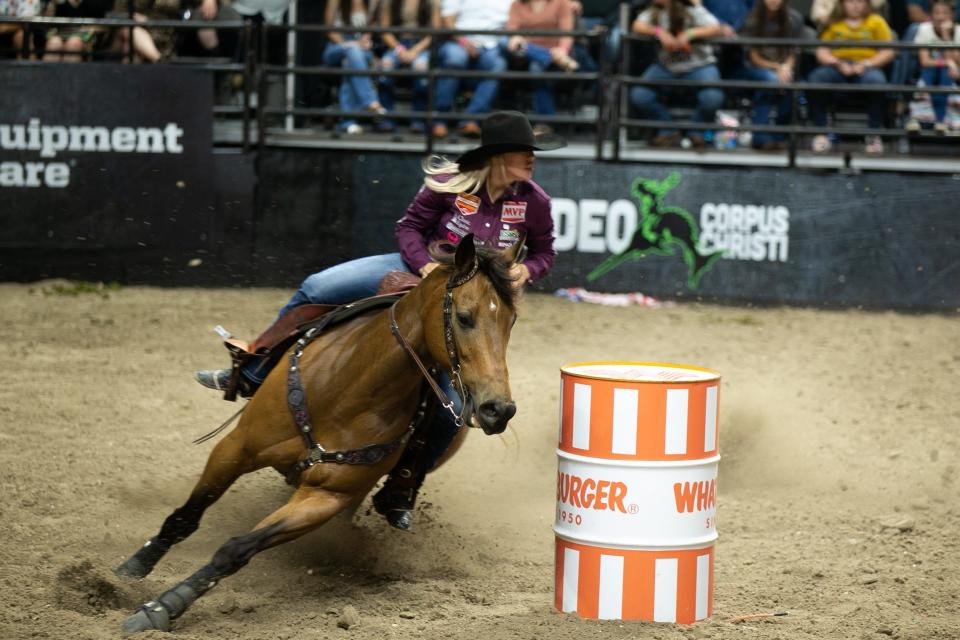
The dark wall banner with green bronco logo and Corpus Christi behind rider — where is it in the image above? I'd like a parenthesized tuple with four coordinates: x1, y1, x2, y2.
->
(284, 151, 960, 310)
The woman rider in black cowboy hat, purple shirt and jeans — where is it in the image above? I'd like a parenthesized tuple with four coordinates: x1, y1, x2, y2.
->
(196, 111, 566, 529)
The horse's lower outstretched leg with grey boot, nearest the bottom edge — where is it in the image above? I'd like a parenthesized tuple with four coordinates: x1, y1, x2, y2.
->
(123, 487, 363, 633)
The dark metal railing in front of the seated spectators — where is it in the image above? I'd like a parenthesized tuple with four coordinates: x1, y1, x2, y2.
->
(0, 13, 960, 166)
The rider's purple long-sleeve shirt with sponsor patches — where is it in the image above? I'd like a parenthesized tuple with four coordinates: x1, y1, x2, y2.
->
(395, 177, 557, 281)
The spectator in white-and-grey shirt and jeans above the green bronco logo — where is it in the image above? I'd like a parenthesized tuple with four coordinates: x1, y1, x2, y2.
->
(630, 0, 724, 149)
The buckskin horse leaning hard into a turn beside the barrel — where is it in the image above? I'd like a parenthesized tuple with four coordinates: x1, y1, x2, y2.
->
(115, 236, 522, 632)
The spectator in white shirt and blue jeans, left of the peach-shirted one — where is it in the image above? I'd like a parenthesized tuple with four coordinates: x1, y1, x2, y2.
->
(433, 0, 511, 138)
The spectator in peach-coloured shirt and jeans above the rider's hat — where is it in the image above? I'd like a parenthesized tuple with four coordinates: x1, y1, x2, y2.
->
(507, 0, 580, 134)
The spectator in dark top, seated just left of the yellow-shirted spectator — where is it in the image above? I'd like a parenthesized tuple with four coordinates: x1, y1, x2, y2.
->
(738, 0, 804, 151)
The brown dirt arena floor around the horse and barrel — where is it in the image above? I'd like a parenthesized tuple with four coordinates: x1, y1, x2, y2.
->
(0, 282, 960, 640)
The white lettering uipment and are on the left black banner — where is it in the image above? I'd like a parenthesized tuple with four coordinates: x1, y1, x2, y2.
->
(0, 118, 184, 188)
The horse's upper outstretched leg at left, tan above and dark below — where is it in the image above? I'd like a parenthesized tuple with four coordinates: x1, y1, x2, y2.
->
(114, 431, 253, 578)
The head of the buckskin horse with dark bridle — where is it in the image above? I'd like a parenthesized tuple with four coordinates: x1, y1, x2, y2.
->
(428, 235, 523, 434)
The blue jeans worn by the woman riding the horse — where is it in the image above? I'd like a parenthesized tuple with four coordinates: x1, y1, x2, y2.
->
(243, 253, 462, 468)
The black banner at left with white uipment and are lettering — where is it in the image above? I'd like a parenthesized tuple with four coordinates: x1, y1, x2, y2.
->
(0, 64, 215, 281)
